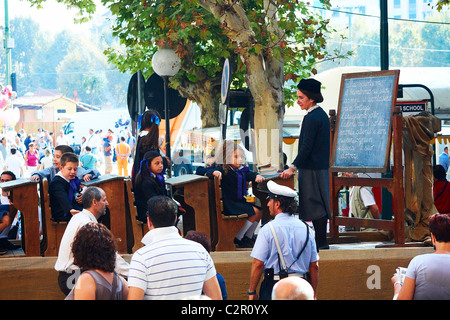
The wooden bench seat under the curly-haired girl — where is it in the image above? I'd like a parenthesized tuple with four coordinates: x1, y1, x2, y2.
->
(214, 177, 248, 251)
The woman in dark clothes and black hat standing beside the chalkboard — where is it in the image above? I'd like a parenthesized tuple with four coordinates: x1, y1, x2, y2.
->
(280, 79, 331, 249)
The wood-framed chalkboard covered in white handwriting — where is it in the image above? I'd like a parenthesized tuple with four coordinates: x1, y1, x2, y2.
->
(330, 70, 400, 172)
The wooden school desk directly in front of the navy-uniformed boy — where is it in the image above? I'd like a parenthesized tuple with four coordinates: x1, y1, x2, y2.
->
(82, 174, 128, 254)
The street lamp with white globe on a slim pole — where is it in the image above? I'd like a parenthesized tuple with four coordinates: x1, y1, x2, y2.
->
(152, 47, 181, 177)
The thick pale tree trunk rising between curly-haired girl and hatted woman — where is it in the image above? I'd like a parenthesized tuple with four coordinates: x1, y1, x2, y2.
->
(199, 0, 284, 168)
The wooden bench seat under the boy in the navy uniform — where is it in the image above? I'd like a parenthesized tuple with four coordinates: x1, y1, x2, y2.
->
(40, 179, 67, 257)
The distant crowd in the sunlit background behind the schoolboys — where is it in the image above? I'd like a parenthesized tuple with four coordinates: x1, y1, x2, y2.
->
(0, 127, 136, 179)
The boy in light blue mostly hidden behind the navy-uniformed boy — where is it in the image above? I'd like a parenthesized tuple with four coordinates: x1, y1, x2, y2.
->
(30, 145, 100, 183)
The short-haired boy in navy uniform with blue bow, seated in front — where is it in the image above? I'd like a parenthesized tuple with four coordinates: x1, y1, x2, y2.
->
(48, 152, 83, 221)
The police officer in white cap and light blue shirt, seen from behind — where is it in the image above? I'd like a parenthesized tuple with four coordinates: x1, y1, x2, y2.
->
(247, 181, 319, 300)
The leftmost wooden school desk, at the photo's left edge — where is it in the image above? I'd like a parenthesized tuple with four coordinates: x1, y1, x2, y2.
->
(0, 179, 41, 257)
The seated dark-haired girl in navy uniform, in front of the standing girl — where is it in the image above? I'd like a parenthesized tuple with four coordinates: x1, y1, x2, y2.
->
(134, 151, 166, 223)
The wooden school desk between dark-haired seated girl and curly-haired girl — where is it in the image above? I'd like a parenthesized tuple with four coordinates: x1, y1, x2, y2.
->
(165, 174, 211, 236)
